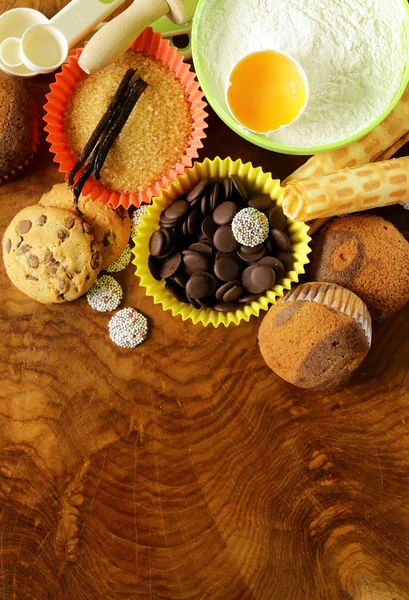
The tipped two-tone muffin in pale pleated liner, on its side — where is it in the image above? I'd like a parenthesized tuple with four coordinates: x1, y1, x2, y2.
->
(258, 283, 371, 390)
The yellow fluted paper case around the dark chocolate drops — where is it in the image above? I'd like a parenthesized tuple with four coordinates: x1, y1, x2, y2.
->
(133, 157, 311, 327)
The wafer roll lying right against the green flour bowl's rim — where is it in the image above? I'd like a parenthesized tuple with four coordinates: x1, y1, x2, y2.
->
(282, 86, 409, 185)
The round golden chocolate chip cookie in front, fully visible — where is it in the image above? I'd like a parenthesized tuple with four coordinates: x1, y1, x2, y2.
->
(2, 204, 102, 304)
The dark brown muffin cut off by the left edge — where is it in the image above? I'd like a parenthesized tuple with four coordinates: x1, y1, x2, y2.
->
(0, 72, 39, 183)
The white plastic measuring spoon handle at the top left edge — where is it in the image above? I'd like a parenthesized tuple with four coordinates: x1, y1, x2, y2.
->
(50, 0, 125, 48)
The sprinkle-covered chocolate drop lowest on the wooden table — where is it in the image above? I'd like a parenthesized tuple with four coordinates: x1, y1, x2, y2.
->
(108, 308, 148, 348)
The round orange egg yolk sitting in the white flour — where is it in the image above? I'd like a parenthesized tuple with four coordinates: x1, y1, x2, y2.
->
(227, 50, 307, 133)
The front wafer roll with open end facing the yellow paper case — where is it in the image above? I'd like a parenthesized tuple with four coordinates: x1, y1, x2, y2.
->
(283, 157, 409, 221)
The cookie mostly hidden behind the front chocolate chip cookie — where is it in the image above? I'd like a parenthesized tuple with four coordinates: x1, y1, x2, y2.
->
(40, 183, 131, 269)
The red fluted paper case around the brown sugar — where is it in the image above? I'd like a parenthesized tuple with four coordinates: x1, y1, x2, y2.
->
(44, 27, 207, 208)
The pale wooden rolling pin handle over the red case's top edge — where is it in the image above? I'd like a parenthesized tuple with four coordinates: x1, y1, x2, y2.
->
(79, 0, 169, 74)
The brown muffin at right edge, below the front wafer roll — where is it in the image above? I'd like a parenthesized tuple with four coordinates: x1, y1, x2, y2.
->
(309, 215, 409, 319)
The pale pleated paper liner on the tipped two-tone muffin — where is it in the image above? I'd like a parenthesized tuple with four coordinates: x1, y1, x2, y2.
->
(281, 282, 372, 346)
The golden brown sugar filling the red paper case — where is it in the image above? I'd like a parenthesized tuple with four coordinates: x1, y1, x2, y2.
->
(65, 50, 192, 193)
